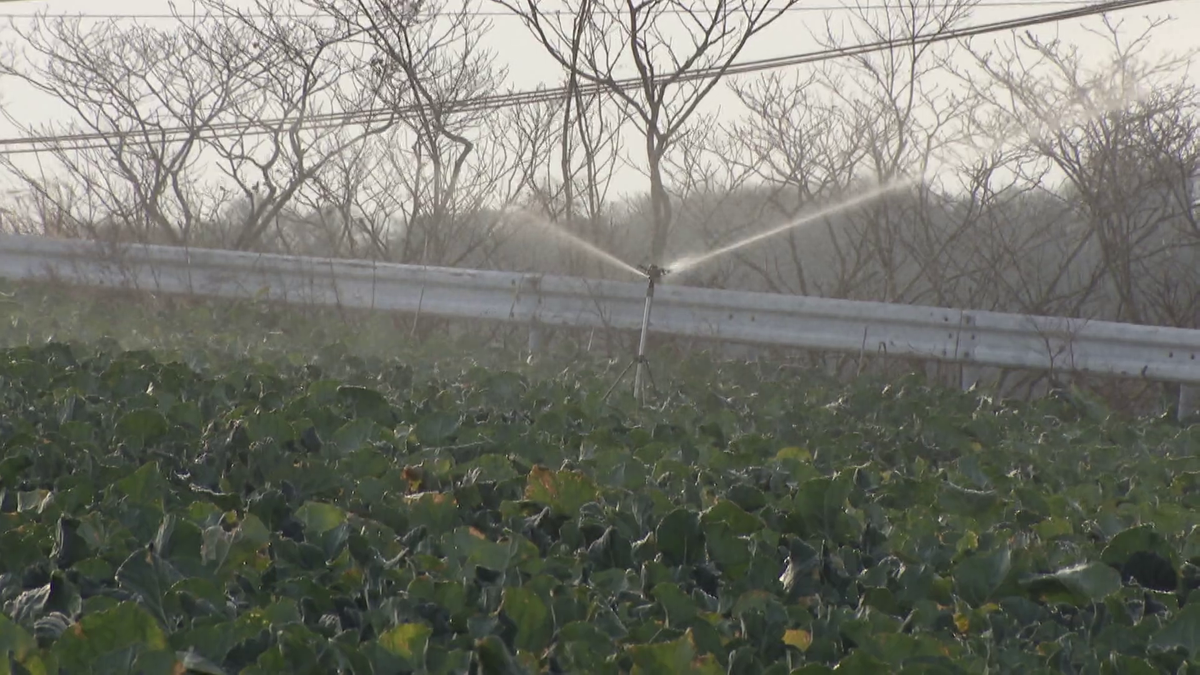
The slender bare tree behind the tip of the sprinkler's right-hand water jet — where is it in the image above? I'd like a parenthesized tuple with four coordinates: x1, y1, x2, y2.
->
(822, 0, 977, 301)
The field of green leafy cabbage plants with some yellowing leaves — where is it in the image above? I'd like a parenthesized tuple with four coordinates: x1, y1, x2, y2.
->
(0, 278, 1200, 675)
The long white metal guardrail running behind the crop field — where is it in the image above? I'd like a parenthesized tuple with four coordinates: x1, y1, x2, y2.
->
(7, 234, 1200, 384)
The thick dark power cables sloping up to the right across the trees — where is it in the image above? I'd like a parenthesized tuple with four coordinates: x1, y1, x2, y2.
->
(0, 0, 1171, 155)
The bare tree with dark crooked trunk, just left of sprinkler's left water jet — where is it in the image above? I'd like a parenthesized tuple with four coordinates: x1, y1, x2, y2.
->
(296, 0, 546, 265)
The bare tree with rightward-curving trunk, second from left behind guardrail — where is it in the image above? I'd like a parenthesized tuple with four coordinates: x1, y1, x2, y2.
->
(192, 0, 397, 249)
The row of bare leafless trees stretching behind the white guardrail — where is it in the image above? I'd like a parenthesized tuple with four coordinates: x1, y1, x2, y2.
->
(0, 0, 1200, 328)
